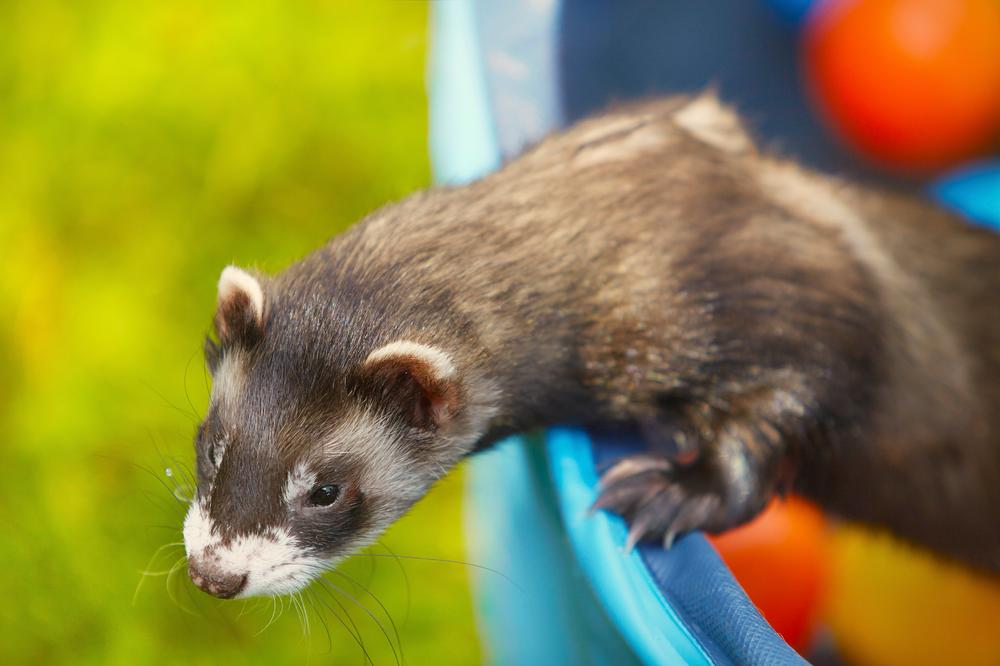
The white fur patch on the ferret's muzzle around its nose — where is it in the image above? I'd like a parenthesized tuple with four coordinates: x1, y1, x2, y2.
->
(184, 502, 328, 599)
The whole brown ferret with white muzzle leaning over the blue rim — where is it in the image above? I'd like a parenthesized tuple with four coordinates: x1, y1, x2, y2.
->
(184, 94, 1000, 598)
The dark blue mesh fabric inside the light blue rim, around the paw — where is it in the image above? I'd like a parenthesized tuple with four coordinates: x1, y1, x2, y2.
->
(591, 431, 807, 665)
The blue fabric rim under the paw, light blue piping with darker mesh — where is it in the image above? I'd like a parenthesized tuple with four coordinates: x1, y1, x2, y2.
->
(546, 428, 806, 664)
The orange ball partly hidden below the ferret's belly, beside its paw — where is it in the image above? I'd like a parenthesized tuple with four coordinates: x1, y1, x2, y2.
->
(710, 498, 829, 653)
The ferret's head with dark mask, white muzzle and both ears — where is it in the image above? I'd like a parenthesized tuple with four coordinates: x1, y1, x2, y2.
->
(184, 267, 490, 598)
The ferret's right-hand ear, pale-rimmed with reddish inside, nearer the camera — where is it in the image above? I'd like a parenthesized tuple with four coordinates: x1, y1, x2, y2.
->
(364, 340, 459, 429)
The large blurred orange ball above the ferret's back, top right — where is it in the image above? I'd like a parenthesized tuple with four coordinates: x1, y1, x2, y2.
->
(804, 0, 1000, 173)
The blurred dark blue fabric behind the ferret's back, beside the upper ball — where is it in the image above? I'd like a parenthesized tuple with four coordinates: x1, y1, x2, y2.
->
(558, 0, 917, 186)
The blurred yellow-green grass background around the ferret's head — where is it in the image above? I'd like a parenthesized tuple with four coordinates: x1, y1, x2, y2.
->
(0, 0, 481, 664)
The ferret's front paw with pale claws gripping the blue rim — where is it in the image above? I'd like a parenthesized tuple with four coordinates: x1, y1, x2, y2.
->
(592, 454, 733, 550)
